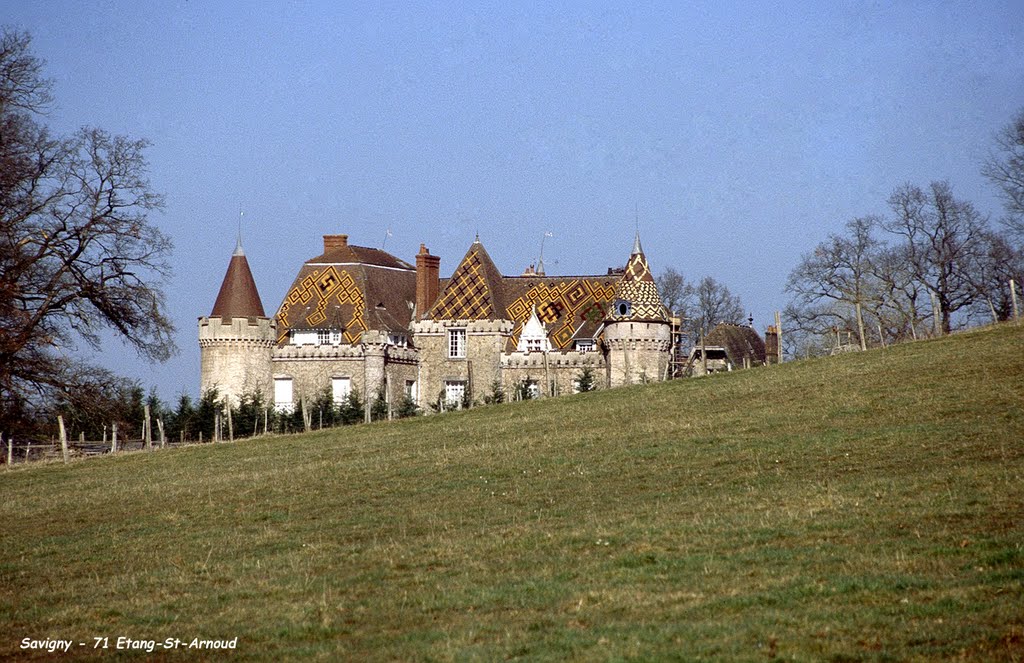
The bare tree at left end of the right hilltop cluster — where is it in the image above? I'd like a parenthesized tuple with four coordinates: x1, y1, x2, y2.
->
(785, 216, 879, 349)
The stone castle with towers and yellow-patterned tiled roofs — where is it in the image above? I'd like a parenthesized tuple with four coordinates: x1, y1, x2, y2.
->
(199, 235, 672, 420)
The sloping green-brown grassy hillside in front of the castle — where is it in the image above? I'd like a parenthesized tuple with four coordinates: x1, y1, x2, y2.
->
(0, 326, 1024, 661)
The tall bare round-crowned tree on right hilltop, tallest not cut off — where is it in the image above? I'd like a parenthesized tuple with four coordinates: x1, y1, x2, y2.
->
(886, 181, 986, 333)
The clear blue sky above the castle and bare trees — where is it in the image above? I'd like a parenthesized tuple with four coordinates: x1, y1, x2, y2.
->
(0, 0, 1024, 399)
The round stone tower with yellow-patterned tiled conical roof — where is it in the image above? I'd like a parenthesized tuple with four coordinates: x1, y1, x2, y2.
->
(603, 233, 672, 387)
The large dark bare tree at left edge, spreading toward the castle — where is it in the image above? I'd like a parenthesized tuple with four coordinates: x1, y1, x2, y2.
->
(0, 31, 174, 430)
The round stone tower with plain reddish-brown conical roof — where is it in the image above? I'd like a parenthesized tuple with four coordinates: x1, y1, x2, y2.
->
(199, 240, 278, 405)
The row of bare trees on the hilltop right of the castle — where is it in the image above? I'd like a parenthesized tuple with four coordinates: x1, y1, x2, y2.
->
(784, 110, 1024, 356)
